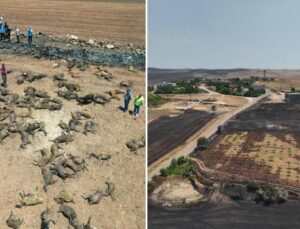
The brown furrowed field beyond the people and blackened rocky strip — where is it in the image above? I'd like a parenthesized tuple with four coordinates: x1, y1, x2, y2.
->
(1, 0, 145, 46)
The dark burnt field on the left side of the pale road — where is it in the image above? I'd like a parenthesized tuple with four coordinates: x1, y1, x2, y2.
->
(148, 109, 213, 164)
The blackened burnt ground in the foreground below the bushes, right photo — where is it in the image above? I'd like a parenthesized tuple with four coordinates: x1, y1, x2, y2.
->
(148, 201, 300, 229)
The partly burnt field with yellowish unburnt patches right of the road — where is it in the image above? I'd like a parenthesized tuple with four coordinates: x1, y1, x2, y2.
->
(193, 102, 300, 188)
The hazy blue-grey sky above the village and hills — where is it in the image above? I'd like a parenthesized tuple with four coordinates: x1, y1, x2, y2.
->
(148, 0, 300, 69)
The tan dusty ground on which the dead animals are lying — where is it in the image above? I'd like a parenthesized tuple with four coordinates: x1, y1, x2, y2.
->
(0, 55, 145, 228)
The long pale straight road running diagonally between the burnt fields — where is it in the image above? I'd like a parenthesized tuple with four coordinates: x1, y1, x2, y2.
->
(148, 89, 271, 180)
